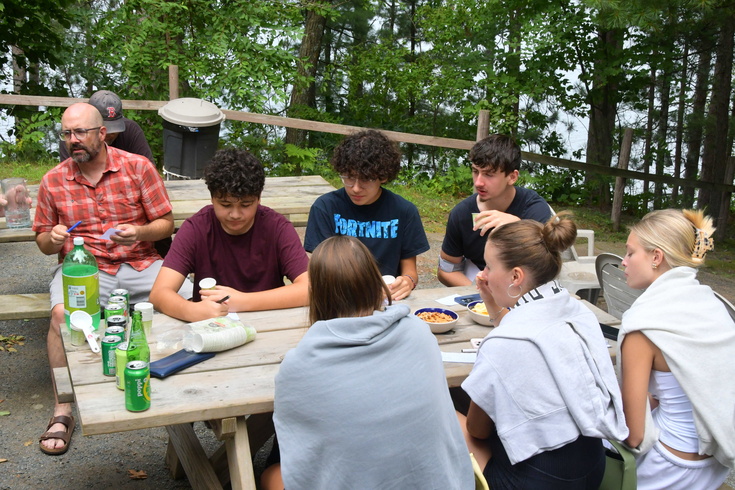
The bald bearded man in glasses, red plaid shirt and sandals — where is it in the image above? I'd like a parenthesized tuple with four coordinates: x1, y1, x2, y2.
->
(33, 103, 174, 455)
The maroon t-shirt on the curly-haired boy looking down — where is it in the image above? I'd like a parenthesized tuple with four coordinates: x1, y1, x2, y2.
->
(163, 205, 309, 301)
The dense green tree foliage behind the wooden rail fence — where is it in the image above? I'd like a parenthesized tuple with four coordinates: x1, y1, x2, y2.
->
(0, 0, 732, 237)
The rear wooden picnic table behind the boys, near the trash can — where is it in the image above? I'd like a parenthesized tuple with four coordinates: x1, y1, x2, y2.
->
(0, 175, 334, 243)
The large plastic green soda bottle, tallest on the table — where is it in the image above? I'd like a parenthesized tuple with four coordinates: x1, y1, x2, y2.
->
(61, 237, 100, 330)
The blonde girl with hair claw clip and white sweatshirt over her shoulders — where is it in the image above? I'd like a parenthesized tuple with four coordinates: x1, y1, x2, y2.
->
(618, 209, 735, 490)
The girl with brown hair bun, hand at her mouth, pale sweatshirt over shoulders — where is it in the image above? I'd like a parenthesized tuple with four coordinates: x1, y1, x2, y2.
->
(458, 215, 628, 490)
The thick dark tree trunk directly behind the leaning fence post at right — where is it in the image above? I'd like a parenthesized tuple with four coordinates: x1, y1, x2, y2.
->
(585, 29, 623, 207)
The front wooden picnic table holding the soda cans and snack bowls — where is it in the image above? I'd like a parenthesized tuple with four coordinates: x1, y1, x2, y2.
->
(60, 286, 615, 489)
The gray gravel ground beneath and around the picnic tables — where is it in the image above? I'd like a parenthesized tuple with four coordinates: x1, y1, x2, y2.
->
(0, 229, 735, 490)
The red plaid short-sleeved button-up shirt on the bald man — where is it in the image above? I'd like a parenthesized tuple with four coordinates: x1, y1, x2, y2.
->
(33, 146, 172, 274)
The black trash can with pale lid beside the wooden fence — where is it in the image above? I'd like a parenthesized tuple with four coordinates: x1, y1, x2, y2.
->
(158, 97, 225, 179)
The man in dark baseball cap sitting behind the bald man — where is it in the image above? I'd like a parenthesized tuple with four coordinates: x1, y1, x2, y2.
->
(59, 90, 153, 162)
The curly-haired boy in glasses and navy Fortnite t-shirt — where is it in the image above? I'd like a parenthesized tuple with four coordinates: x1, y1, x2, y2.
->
(304, 130, 429, 300)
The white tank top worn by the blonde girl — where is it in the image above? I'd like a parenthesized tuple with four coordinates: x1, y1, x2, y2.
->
(648, 370, 699, 453)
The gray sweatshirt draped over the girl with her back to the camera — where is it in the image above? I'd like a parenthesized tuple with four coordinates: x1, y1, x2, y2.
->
(274, 305, 474, 490)
